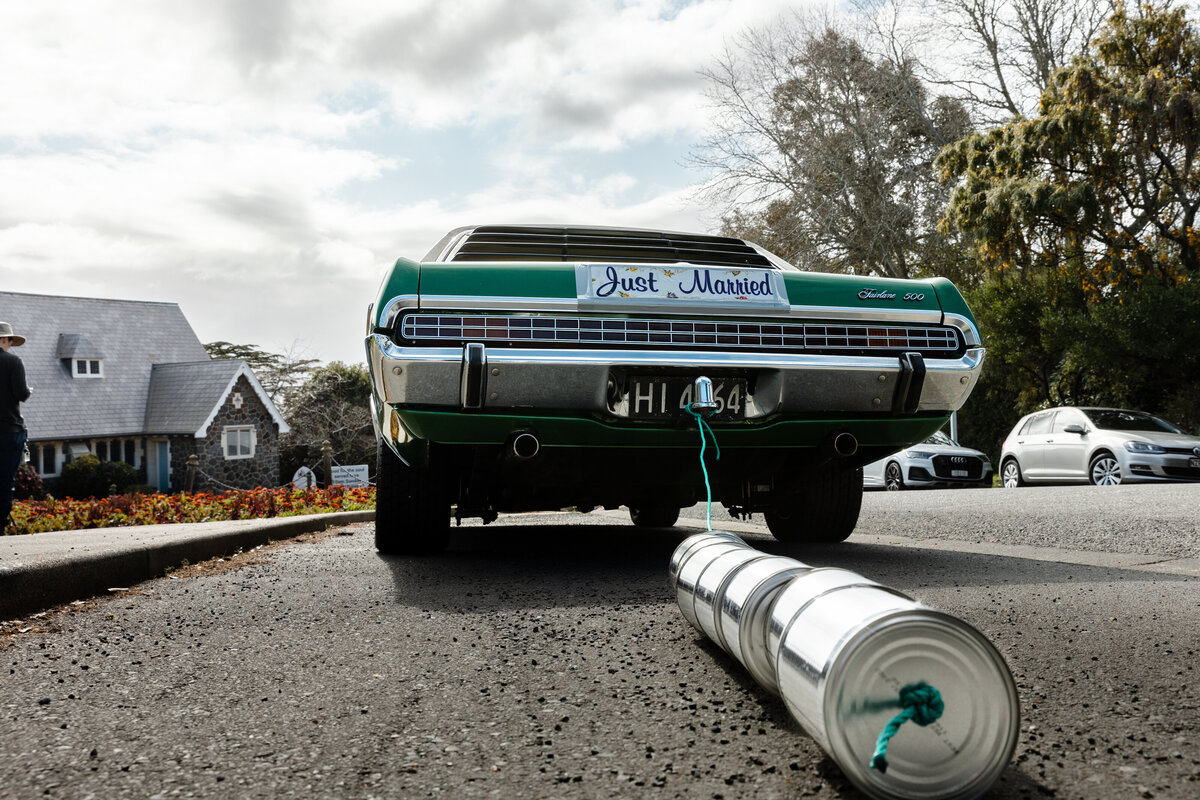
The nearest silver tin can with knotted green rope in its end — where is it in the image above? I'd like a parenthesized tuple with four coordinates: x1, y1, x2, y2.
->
(773, 578, 1020, 800)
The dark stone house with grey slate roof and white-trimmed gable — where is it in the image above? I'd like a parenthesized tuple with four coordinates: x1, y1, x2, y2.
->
(0, 291, 289, 492)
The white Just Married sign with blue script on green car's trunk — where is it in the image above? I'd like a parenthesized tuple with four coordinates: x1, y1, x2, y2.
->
(583, 264, 786, 306)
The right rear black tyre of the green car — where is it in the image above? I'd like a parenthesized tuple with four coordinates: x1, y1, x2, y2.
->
(763, 465, 863, 545)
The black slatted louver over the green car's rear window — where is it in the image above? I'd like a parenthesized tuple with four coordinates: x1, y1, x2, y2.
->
(449, 225, 774, 269)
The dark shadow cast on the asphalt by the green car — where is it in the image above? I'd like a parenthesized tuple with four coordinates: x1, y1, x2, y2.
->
(380, 524, 1187, 612)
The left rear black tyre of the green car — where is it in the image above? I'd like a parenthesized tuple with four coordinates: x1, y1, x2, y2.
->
(376, 441, 450, 555)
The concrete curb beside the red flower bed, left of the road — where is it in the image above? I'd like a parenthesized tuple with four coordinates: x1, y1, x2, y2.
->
(0, 511, 374, 619)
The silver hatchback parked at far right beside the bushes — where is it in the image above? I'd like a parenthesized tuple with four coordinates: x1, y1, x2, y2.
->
(1000, 407, 1200, 489)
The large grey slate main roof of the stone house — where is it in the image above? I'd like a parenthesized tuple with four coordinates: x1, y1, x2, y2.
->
(0, 291, 216, 440)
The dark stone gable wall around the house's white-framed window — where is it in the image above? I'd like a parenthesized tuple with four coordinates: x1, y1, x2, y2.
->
(183, 375, 280, 492)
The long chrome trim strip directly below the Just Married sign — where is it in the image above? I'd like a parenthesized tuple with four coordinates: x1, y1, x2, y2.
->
(412, 295, 945, 327)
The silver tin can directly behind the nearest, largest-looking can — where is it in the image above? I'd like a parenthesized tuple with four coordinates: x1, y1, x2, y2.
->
(716, 555, 812, 692)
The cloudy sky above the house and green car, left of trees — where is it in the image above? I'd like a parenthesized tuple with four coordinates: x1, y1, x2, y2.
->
(0, 0, 803, 361)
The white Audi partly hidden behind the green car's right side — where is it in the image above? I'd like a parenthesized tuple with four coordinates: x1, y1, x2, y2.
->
(863, 431, 991, 492)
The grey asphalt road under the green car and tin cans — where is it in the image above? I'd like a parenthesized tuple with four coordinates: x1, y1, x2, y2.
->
(0, 486, 1200, 799)
